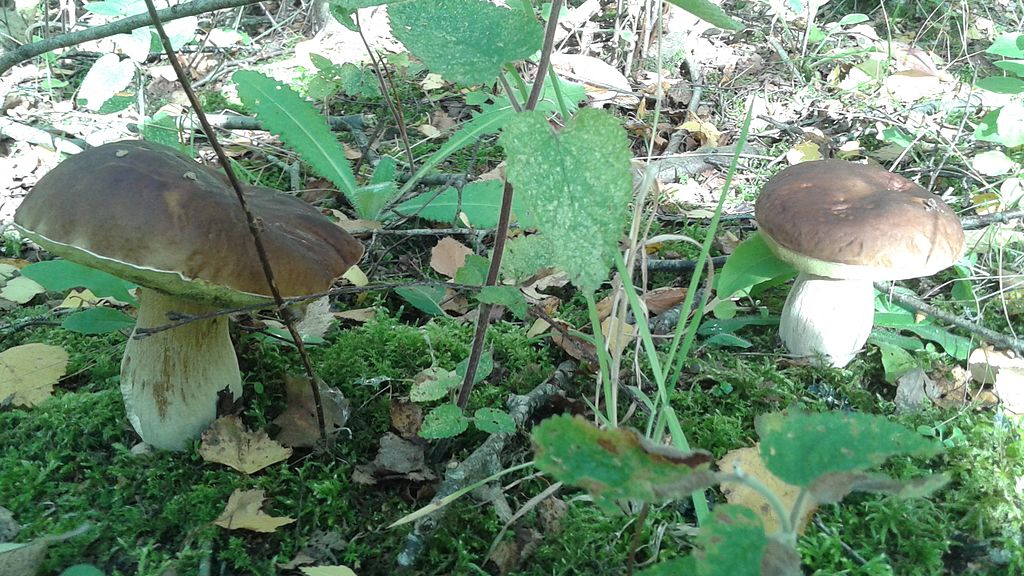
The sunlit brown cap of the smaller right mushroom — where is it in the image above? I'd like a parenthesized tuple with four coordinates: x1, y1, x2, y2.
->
(755, 160, 964, 280)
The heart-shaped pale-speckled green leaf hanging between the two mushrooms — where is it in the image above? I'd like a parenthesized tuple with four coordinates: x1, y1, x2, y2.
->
(501, 109, 633, 292)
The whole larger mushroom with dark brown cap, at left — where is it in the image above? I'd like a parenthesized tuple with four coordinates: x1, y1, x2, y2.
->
(14, 140, 362, 450)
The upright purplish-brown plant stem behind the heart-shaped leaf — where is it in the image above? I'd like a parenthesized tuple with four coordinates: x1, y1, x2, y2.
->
(456, 0, 568, 409)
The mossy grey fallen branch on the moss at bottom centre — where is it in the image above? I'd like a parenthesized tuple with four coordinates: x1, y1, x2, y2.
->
(398, 361, 575, 567)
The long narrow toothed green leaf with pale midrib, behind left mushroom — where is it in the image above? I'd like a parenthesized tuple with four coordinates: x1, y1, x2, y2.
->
(231, 70, 355, 204)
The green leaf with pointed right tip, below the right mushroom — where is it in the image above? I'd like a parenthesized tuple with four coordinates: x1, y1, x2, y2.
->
(755, 412, 942, 487)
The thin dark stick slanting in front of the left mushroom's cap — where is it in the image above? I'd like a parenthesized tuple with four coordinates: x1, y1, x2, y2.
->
(145, 0, 329, 442)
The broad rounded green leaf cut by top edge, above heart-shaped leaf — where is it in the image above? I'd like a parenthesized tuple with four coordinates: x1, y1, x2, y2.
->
(388, 0, 544, 84)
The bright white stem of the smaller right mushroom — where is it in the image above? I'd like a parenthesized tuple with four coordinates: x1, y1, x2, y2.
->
(779, 273, 874, 368)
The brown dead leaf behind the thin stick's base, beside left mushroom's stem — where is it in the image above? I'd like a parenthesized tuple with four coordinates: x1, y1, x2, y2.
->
(273, 374, 348, 448)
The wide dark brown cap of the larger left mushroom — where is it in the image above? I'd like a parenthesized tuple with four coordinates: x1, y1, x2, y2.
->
(14, 140, 362, 306)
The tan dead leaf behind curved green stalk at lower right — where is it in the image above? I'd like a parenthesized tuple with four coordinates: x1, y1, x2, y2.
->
(718, 445, 814, 534)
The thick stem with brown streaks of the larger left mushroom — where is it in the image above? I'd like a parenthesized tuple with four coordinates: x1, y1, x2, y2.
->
(121, 288, 242, 450)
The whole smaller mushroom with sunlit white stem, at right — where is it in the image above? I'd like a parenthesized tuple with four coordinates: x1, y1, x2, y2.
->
(755, 160, 964, 367)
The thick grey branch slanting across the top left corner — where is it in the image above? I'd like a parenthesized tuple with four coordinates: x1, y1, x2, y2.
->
(0, 0, 261, 75)
